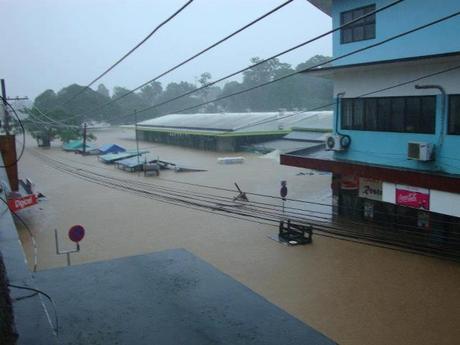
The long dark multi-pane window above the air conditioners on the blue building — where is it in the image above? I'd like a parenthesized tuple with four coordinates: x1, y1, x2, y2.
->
(341, 95, 434, 134)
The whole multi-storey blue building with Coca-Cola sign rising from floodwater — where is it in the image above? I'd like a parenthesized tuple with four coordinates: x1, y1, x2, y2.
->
(281, 0, 460, 252)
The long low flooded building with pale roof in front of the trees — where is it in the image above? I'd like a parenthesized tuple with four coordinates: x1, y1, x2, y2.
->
(133, 111, 332, 152)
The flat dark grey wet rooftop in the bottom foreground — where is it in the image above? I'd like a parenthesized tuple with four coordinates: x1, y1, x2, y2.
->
(37, 249, 335, 345)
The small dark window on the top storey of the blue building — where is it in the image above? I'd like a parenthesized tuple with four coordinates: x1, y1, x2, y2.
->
(340, 5, 375, 43)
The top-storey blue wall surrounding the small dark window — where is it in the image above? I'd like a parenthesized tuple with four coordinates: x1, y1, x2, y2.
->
(332, 0, 460, 66)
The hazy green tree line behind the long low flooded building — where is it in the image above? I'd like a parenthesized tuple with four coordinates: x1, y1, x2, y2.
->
(26, 55, 332, 138)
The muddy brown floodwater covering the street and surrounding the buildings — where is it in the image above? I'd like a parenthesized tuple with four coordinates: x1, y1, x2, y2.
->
(13, 129, 460, 345)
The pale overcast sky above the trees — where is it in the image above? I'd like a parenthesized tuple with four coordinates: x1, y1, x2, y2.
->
(0, 0, 331, 99)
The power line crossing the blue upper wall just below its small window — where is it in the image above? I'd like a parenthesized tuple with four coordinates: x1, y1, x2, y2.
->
(121, 11, 460, 118)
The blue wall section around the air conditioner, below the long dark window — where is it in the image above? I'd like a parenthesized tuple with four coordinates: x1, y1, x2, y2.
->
(334, 96, 460, 174)
